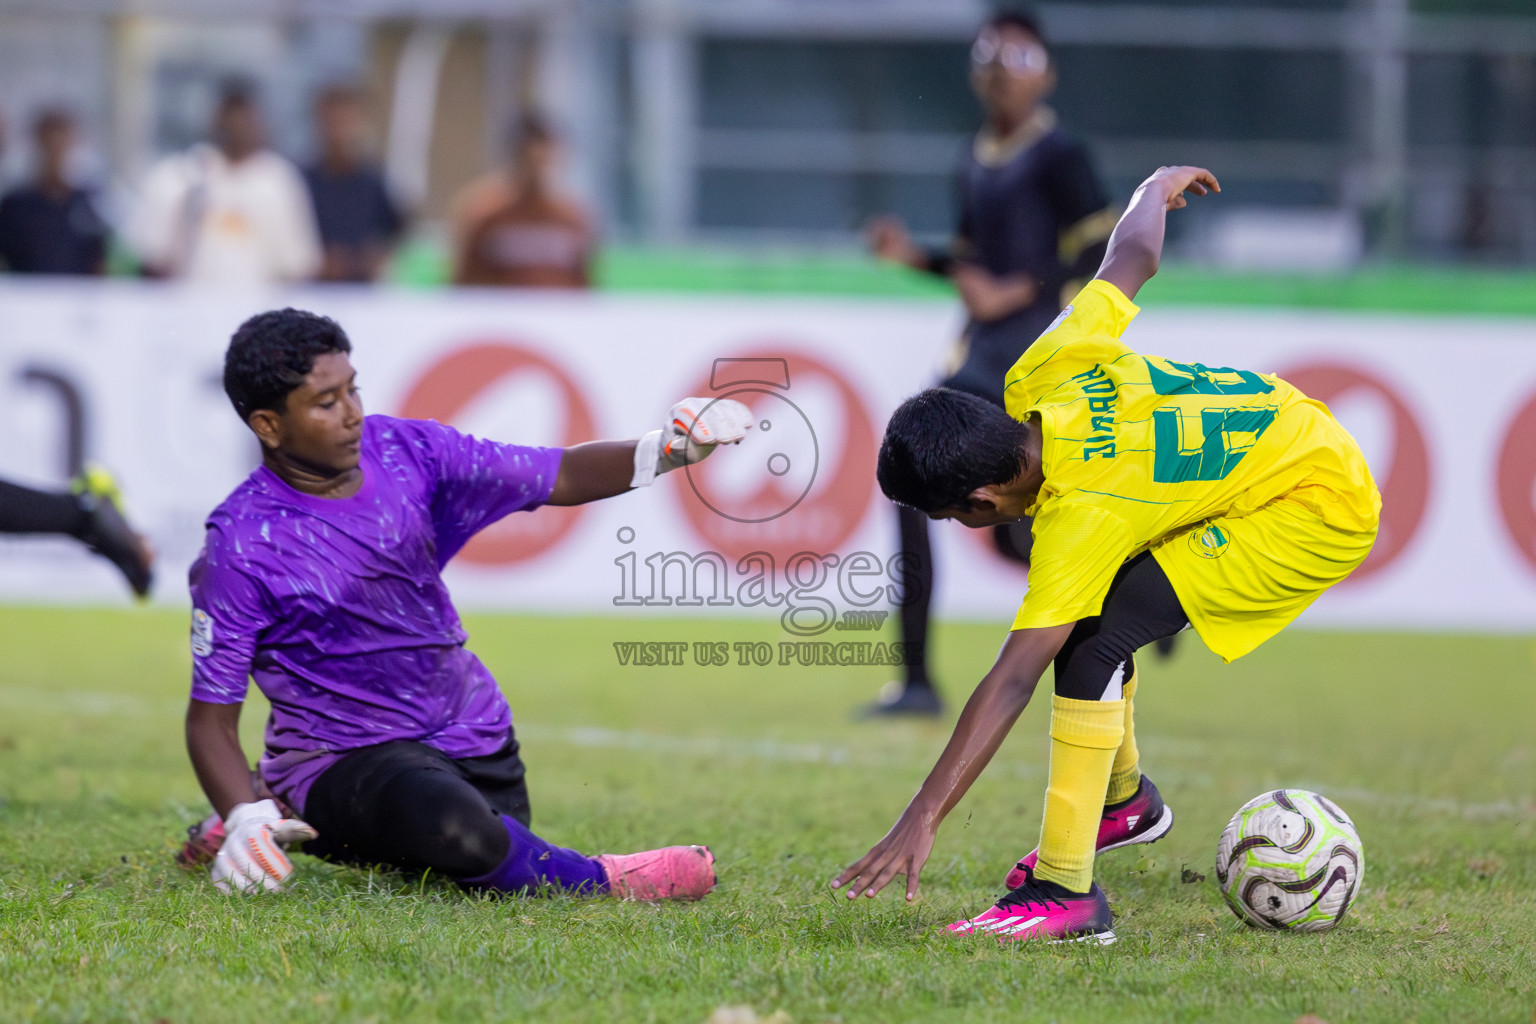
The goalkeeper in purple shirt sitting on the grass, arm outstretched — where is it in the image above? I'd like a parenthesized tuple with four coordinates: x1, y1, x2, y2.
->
(183, 309, 751, 900)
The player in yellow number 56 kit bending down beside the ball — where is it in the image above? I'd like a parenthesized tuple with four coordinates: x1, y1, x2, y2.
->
(833, 167, 1381, 943)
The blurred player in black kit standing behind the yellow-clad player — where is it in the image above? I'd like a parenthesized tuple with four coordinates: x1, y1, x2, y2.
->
(868, 11, 1115, 715)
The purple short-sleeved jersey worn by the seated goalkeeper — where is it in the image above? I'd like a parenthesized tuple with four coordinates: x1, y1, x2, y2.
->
(190, 416, 561, 811)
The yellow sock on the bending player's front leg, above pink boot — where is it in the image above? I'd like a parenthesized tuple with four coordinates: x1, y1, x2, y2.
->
(1035, 697, 1126, 892)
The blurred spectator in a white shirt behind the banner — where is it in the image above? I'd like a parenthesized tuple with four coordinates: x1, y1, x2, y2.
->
(132, 88, 319, 284)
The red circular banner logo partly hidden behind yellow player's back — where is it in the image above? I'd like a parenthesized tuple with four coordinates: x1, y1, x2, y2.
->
(1279, 362, 1430, 580)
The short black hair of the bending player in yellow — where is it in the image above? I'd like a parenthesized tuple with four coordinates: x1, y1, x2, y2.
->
(876, 387, 1026, 516)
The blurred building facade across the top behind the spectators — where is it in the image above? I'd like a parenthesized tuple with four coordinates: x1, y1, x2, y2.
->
(0, 0, 1536, 264)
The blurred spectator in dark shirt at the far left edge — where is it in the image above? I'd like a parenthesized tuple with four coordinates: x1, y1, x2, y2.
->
(0, 107, 108, 275)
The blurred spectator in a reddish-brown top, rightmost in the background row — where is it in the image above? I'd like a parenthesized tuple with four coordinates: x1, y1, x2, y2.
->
(453, 114, 593, 289)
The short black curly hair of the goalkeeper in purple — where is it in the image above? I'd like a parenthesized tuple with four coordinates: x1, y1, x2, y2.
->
(224, 309, 352, 421)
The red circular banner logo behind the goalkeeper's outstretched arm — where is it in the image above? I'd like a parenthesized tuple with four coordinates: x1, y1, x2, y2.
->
(399, 341, 596, 565)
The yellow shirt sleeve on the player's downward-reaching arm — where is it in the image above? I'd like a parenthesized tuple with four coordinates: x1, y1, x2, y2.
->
(1012, 500, 1137, 629)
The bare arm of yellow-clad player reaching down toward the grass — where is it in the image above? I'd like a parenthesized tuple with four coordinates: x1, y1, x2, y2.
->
(833, 623, 1072, 900)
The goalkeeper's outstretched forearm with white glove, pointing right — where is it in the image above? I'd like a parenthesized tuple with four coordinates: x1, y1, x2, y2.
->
(545, 398, 753, 505)
